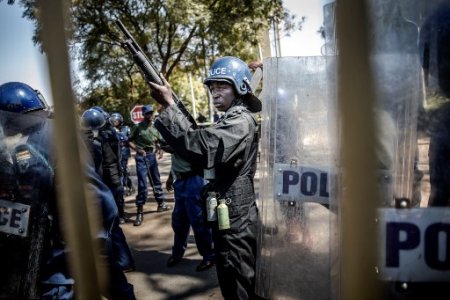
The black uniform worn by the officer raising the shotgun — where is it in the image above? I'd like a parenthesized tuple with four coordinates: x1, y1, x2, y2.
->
(155, 106, 258, 299)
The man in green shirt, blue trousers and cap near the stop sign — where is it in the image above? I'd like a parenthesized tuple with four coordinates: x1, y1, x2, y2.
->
(128, 105, 171, 226)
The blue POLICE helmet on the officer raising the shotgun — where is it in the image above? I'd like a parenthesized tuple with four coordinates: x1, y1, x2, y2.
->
(203, 56, 262, 112)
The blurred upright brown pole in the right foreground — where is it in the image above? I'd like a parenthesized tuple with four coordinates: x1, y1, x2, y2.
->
(336, 0, 379, 300)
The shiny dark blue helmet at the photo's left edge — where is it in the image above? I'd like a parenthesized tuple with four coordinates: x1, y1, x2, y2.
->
(0, 82, 48, 113)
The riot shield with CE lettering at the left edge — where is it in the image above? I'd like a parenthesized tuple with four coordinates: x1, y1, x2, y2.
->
(0, 111, 54, 299)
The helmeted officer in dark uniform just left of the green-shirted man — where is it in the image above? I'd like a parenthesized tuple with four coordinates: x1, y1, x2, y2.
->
(109, 112, 134, 196)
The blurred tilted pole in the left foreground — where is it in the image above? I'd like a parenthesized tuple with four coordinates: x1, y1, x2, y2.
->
(38, 0, 101, 299)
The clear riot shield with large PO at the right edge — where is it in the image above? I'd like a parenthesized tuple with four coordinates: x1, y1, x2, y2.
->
(369, 0, 450, 299)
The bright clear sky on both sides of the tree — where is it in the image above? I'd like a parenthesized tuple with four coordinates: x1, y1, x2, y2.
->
(0, 0, 330, 105)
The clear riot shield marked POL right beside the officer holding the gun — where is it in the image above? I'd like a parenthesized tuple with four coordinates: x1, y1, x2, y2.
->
(256, 57, 337, 299)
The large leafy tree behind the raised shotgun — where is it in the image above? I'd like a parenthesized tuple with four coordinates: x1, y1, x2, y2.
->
(0, 0, 302, 123)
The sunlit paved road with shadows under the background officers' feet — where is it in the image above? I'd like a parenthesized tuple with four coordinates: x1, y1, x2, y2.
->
(122, 154, 223, 300)
